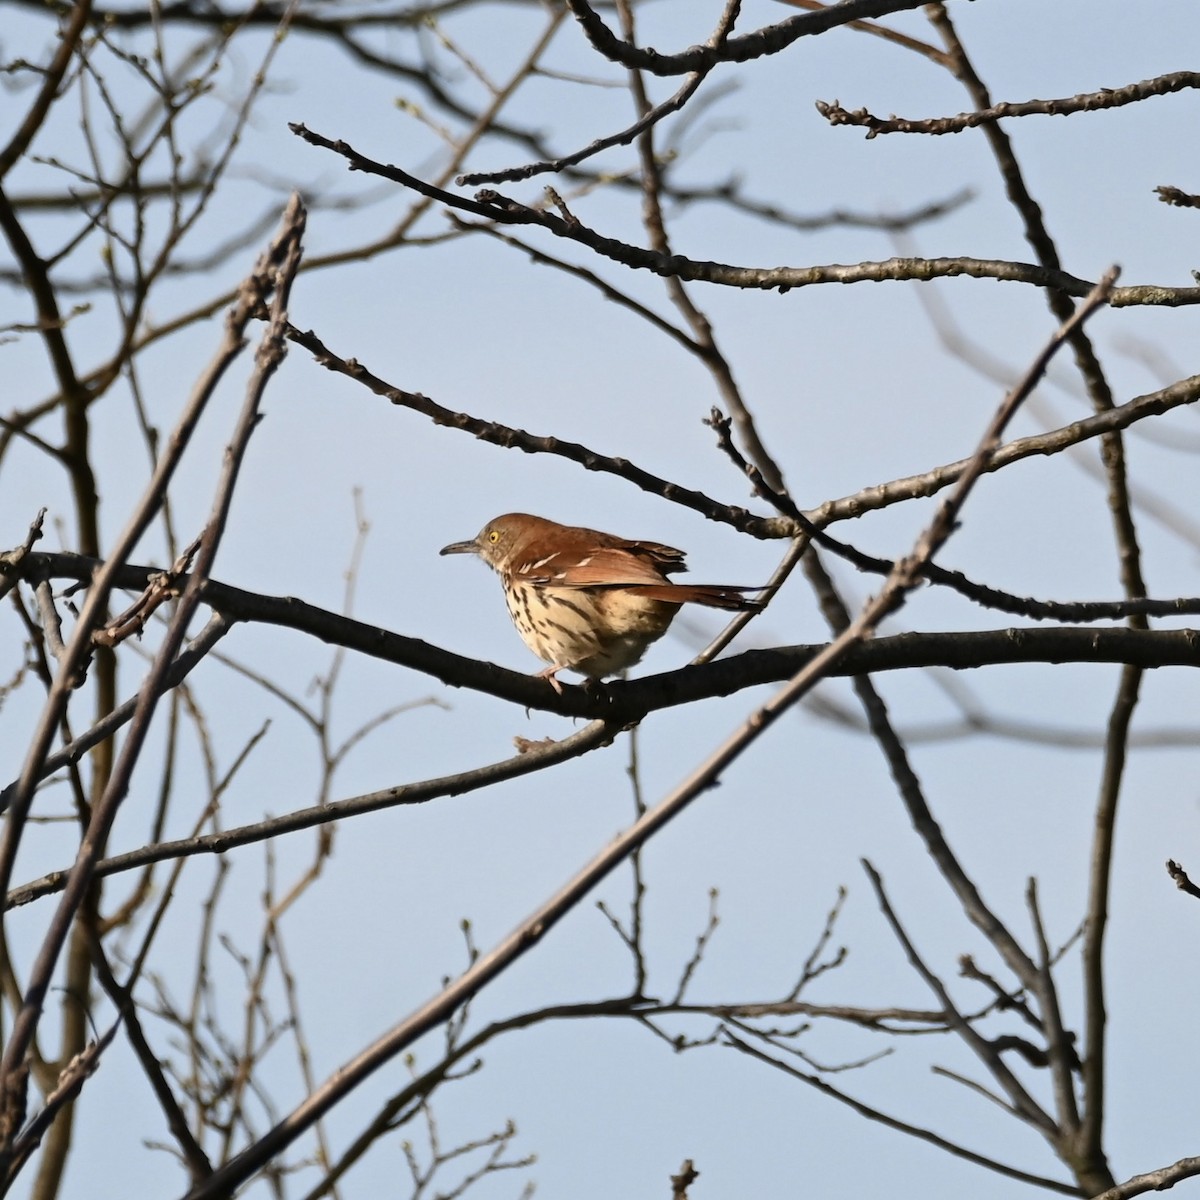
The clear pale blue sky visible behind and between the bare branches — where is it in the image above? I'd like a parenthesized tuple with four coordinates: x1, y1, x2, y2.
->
(0, 0, 1200, 1200)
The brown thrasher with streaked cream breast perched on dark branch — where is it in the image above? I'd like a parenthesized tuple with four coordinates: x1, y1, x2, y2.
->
(440, 512, 760, 692)
